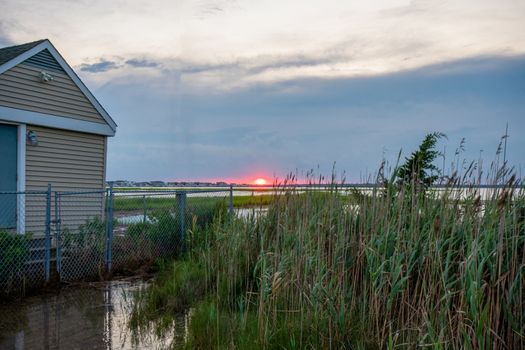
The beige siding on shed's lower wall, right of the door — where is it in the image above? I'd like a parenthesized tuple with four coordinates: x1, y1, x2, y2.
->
(25, 125, 106, 234)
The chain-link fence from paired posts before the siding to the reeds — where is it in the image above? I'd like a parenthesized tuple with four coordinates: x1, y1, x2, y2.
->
(54, 187, 232, 281)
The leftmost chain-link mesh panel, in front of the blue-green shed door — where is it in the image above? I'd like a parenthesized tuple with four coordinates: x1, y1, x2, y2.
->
(0, 192, 48, 293)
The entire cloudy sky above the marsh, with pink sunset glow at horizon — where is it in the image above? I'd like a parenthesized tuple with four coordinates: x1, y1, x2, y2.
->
(0, 0, 525, 182)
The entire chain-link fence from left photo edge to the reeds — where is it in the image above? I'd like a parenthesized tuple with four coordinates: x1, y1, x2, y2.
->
(0, 186, 233, 294)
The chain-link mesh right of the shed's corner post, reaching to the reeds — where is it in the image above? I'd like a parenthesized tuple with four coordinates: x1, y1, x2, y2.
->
(112, 190, 229, 271)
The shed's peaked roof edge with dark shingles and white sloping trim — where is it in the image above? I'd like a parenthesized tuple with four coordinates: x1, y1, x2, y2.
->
(0, 39, 117, 136)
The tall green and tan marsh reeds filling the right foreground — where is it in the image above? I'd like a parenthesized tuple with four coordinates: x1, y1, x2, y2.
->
(129, 175, 525, 349)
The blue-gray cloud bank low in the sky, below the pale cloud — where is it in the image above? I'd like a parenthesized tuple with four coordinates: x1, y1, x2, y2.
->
(95, 57, 525, 181)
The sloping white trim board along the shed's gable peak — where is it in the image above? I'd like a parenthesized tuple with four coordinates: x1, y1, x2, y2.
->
(0, 40, 117, 135)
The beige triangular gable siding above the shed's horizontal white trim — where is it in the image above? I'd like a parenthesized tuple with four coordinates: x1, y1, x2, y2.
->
(0, 63, 105, 124)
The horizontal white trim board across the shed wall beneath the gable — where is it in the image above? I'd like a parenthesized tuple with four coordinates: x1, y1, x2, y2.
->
(0, 106, 115, 135)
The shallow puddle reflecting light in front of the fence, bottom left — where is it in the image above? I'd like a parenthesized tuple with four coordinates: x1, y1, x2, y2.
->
(0, 280, 188, 350)
